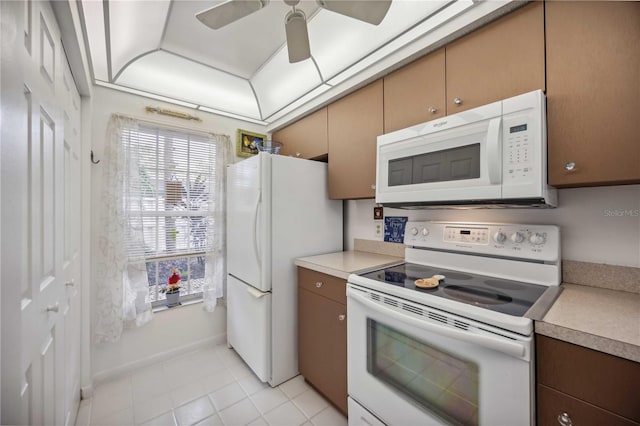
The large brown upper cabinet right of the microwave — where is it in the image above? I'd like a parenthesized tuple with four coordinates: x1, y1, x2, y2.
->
(546, 1, 640, 186)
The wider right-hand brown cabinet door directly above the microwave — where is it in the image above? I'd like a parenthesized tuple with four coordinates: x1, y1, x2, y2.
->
(446, 2, 545, 114)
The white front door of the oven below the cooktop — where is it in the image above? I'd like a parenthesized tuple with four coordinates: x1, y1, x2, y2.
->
(347, 284, 534, 426)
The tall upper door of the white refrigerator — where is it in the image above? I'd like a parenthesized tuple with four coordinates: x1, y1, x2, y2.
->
(227, 155, 271, 291)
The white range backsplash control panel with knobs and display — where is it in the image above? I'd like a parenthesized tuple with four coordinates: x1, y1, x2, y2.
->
(404, 221, 560, 261)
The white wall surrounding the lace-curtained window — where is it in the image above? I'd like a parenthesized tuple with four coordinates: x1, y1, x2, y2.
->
(91, 86, 265, 378)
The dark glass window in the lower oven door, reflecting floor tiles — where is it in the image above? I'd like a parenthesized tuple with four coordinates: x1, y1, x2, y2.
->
(367, 319, 479, 425)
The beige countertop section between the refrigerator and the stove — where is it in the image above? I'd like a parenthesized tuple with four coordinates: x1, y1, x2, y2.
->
(295, 251, 404, 280)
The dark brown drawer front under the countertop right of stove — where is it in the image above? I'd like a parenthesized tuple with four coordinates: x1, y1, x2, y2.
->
(536, 335, 640, 424)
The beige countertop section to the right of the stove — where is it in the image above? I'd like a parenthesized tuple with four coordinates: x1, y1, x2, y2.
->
(535, 284, 640, 362)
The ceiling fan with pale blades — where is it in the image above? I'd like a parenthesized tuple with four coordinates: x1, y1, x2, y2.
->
(196, 0, 392, 63)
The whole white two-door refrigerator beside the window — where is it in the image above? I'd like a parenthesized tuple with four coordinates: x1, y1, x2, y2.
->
(227, 152, 343, 386)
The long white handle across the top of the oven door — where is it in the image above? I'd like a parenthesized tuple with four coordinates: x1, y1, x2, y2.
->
(347, 289, 525, 358)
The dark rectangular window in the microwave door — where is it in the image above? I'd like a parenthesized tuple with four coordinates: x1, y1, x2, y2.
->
(387, 143, 480, 186)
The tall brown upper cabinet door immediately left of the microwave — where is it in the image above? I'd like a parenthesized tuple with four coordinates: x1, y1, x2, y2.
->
(328, 80, 383, 200)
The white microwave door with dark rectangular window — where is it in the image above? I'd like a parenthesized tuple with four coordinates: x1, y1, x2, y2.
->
(376, 102, 503, 203)
